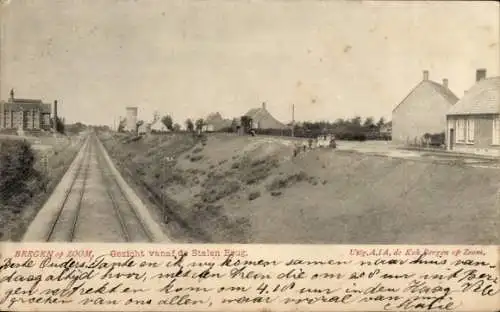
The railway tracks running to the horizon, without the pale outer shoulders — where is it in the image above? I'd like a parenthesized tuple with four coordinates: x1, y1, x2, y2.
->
(45, 136, 153, 242)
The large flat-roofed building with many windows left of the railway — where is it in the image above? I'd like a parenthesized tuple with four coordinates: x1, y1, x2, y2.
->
(0, 90, 51, 130)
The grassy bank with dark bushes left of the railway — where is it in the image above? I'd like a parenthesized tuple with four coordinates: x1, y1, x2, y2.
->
(0, 135, 82, 241)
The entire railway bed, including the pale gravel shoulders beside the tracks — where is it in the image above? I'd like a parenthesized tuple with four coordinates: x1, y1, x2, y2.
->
(23, 134, 168, 242)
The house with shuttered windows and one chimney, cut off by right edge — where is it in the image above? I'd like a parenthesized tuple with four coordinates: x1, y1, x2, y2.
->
(446, 69, 500, 156)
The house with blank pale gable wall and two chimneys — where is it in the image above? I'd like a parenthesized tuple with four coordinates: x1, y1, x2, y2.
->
(392, 70, 458, 144)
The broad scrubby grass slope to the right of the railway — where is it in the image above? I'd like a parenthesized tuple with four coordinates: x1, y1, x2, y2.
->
(96, 134, 500, 244)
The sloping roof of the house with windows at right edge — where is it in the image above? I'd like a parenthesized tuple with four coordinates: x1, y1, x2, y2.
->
(448, 77, 500, 115)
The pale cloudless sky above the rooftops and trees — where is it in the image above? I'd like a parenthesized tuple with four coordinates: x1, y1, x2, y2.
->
(0, 0, 500, 125)
